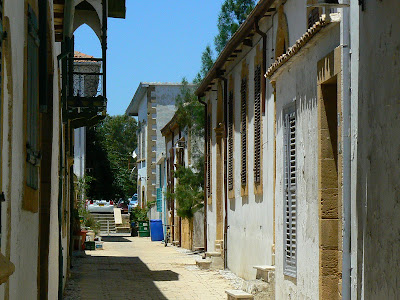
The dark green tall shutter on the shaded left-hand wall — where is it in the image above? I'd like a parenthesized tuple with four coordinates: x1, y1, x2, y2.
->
(26, 6, 40, 190)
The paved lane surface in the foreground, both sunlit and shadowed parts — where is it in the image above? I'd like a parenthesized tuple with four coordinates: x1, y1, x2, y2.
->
(64, 236, 232, 300)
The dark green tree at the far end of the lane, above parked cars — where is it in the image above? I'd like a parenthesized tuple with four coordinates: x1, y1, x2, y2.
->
(87, 115, 137, 199)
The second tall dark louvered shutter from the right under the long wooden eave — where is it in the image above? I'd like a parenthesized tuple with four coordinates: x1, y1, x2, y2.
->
(240, 78, 247, 185)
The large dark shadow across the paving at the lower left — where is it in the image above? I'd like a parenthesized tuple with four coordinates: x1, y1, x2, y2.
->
(64, 255, 179, 300)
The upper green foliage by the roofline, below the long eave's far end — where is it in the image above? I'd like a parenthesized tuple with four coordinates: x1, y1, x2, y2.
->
(175, 78, 205, 137)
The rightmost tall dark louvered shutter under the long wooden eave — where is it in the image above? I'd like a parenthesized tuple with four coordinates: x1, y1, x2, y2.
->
(254, 65, 261, 183)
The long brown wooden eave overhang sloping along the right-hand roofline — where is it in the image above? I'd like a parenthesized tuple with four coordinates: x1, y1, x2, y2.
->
(195, 0, 277, 97)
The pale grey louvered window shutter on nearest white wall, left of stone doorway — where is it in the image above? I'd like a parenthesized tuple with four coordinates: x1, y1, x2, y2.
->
(284, 106, 297, 277)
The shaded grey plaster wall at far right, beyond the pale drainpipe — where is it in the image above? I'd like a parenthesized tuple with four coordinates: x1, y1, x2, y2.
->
(358, 0, 400, 299)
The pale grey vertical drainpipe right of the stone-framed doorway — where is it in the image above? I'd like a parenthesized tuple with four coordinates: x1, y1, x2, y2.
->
(340, 5, 352, 300)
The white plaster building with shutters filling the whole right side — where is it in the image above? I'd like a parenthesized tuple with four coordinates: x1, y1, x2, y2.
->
(197, 0, 400, 299)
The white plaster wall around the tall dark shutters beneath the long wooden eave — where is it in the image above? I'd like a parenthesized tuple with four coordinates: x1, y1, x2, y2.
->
(223, 34, 274, 279)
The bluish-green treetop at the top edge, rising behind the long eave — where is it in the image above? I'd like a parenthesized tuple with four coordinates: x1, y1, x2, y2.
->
(214, 0, 255, 54)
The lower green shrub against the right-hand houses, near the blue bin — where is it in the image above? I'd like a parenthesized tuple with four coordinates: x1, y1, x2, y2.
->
(166, 157, 204, 220)
